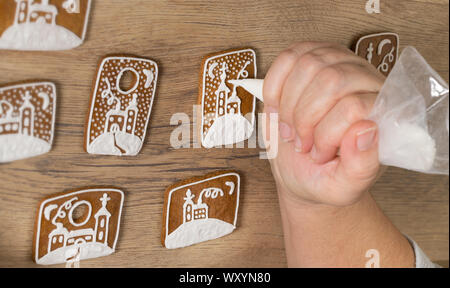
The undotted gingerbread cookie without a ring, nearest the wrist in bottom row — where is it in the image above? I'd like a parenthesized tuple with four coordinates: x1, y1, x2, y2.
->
(161, 171, 240, 249)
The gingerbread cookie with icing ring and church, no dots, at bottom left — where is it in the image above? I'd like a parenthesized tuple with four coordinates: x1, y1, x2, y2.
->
(33, 188, 124, 265)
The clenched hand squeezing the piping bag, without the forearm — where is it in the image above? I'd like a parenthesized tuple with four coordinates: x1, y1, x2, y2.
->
(263, 42, 385, 206)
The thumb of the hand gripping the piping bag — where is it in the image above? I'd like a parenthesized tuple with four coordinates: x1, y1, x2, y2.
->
(336, 120, 380, 187)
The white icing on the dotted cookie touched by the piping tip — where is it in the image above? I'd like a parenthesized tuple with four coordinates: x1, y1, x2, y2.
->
(201, 49, 257, 148)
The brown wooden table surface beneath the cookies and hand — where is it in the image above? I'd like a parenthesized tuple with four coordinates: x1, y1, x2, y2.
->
(0, 0, 449, 267)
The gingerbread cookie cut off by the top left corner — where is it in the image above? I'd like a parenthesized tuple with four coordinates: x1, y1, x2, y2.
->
(0, 0, 91, 50)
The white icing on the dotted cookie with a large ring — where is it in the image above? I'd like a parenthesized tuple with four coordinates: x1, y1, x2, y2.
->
(86, 57, 158, 156)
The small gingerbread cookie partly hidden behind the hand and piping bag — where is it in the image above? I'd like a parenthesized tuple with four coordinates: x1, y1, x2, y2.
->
(355, 33, 399, 76)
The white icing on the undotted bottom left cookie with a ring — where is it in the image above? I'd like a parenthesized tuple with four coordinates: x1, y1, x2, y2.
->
(34, 189, 124, 265)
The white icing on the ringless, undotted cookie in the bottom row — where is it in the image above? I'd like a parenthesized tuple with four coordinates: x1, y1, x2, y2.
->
(164, 173, 240, 249)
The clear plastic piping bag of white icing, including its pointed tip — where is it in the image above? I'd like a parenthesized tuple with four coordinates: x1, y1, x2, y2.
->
(229, 47, 449, 175)
